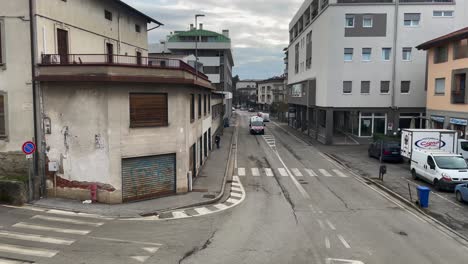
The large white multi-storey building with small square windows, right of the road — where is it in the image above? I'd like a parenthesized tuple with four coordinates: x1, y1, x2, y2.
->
(287, 0, 468, 144)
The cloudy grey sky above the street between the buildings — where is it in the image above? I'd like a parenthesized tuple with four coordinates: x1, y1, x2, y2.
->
(124, 0, 303, 79)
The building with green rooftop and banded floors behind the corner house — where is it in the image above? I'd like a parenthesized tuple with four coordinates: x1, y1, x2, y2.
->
(159, 24, 234, 93)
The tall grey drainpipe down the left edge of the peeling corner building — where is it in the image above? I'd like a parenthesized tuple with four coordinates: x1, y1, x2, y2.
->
(29, 0, 39, 197)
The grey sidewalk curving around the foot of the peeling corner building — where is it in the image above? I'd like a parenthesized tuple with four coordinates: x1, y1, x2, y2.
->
(33, 125, 235, 217)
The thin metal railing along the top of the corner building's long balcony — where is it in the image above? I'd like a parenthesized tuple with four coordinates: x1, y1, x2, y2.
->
(40, 54, 208, 80)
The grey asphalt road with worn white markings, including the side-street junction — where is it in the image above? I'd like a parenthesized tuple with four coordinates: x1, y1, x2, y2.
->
(0, 112, 468, 264)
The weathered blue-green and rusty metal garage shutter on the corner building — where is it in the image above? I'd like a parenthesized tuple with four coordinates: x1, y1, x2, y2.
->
(122, 154, 176, 202)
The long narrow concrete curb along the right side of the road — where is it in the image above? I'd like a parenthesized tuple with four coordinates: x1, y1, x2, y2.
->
(324, 153, 468, 246)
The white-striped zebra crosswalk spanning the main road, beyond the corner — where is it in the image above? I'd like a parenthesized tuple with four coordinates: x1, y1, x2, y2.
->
(237, 168, 349, 178)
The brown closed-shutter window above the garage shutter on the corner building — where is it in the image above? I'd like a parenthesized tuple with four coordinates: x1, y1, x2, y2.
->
(130, 93, 168, 127)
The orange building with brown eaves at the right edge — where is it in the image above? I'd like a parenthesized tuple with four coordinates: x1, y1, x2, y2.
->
(417, 27, 468, 139)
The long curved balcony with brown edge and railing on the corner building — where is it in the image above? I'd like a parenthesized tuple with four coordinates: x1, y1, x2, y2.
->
(37, 54, 213, 88)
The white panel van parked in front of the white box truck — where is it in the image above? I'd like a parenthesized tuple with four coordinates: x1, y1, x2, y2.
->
(411, 149, 468, 190)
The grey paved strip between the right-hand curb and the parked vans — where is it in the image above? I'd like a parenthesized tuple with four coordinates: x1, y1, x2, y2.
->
(272, 120, 468, 240)
